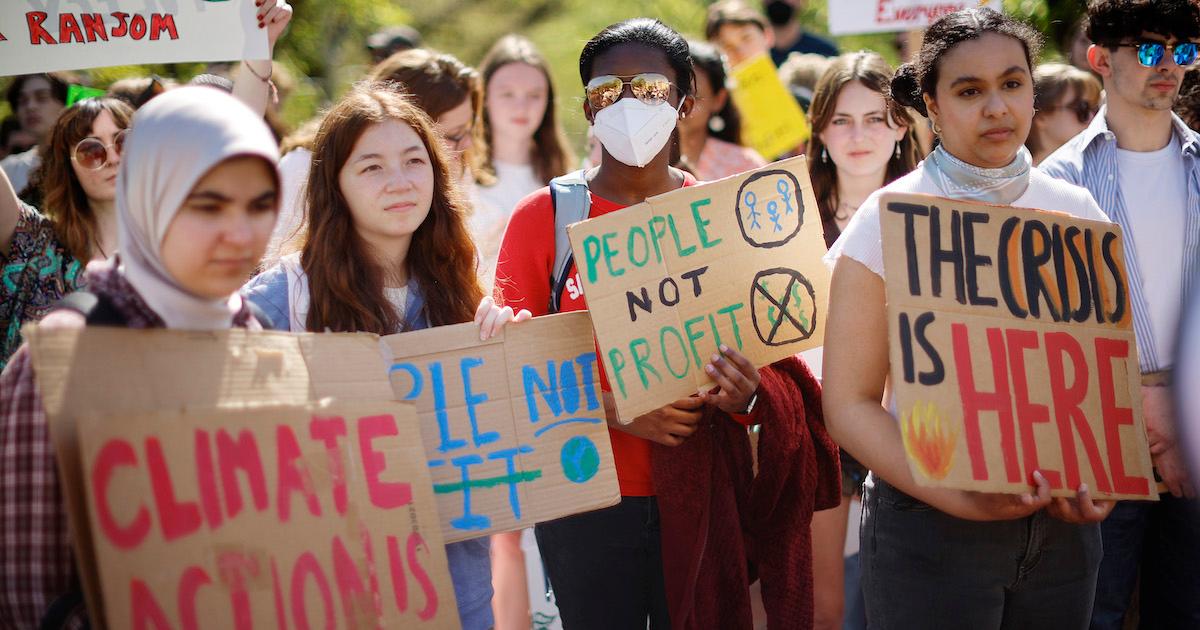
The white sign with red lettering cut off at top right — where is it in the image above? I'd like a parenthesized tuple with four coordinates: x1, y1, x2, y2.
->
(829, 0, 1003, 35)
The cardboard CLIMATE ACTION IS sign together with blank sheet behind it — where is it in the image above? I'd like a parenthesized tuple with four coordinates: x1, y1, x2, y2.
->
(25, 326, 458, 629)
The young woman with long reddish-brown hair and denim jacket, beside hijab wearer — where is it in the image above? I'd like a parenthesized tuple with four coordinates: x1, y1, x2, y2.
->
(246, 83, 529, 629)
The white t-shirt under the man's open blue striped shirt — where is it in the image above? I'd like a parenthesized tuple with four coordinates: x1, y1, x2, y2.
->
(1117, 134, 1188, 366)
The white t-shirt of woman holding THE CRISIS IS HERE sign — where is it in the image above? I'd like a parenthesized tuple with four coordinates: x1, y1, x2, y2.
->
(824, 162, 1109, 277)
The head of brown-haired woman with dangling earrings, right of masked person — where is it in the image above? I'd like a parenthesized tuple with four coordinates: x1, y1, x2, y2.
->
(805, 50, 918, 246)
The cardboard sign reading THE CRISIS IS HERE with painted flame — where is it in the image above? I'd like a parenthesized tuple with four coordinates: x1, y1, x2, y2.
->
(880, 194, 1157, 499)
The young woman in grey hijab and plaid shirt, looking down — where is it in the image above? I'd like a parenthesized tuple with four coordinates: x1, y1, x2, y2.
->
(0, 88, 278, 629)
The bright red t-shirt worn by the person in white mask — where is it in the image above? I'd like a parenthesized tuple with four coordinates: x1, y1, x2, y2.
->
(496, 175, 696, 497)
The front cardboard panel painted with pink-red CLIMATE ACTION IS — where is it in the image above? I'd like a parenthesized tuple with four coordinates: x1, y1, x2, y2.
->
(79, 402, 458, 628)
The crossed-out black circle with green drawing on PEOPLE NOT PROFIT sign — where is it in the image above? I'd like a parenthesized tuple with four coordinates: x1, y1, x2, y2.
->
(750, 268, 817, 346)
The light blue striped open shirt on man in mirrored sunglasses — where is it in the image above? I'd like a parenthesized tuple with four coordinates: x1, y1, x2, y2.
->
(1038, 107, 1200, 373)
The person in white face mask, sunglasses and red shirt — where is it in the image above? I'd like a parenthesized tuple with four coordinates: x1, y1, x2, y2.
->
(496, 18, 836, 630)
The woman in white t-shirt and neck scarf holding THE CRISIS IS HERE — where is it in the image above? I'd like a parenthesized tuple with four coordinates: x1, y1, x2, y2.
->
(823, 10, 1112, 630)
